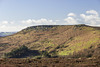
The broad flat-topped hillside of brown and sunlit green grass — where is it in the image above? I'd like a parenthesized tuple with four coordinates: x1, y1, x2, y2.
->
(0, 24, 100, 57)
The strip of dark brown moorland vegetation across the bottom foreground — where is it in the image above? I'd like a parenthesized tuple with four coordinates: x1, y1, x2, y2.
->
(0, 58, 100, 67)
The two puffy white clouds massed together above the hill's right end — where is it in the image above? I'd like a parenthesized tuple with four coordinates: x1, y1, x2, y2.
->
(64, 10, 100, 26)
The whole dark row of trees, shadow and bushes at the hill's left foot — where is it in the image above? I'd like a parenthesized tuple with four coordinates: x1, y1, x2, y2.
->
(4, 45, 51, 58)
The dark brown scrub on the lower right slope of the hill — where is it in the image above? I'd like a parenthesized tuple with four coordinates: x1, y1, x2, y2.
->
(66, 44, 100, 58)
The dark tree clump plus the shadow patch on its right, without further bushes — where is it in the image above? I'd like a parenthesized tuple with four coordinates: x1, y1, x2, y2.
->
(5, 46, 41, 58)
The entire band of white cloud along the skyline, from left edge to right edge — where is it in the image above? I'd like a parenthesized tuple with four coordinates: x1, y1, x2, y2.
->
(0, 10, 100, 32)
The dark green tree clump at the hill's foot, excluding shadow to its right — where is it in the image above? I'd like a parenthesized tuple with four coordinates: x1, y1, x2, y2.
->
(5, 45, 30, 58)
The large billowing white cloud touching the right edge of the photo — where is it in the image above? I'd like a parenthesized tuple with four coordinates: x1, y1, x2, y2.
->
(80, 10, 100, 26)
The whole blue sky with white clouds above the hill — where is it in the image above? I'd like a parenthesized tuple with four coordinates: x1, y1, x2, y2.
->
(0, 0, 100, 32)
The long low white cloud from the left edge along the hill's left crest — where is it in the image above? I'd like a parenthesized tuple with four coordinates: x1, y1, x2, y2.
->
(0, 18, 56, 32)
